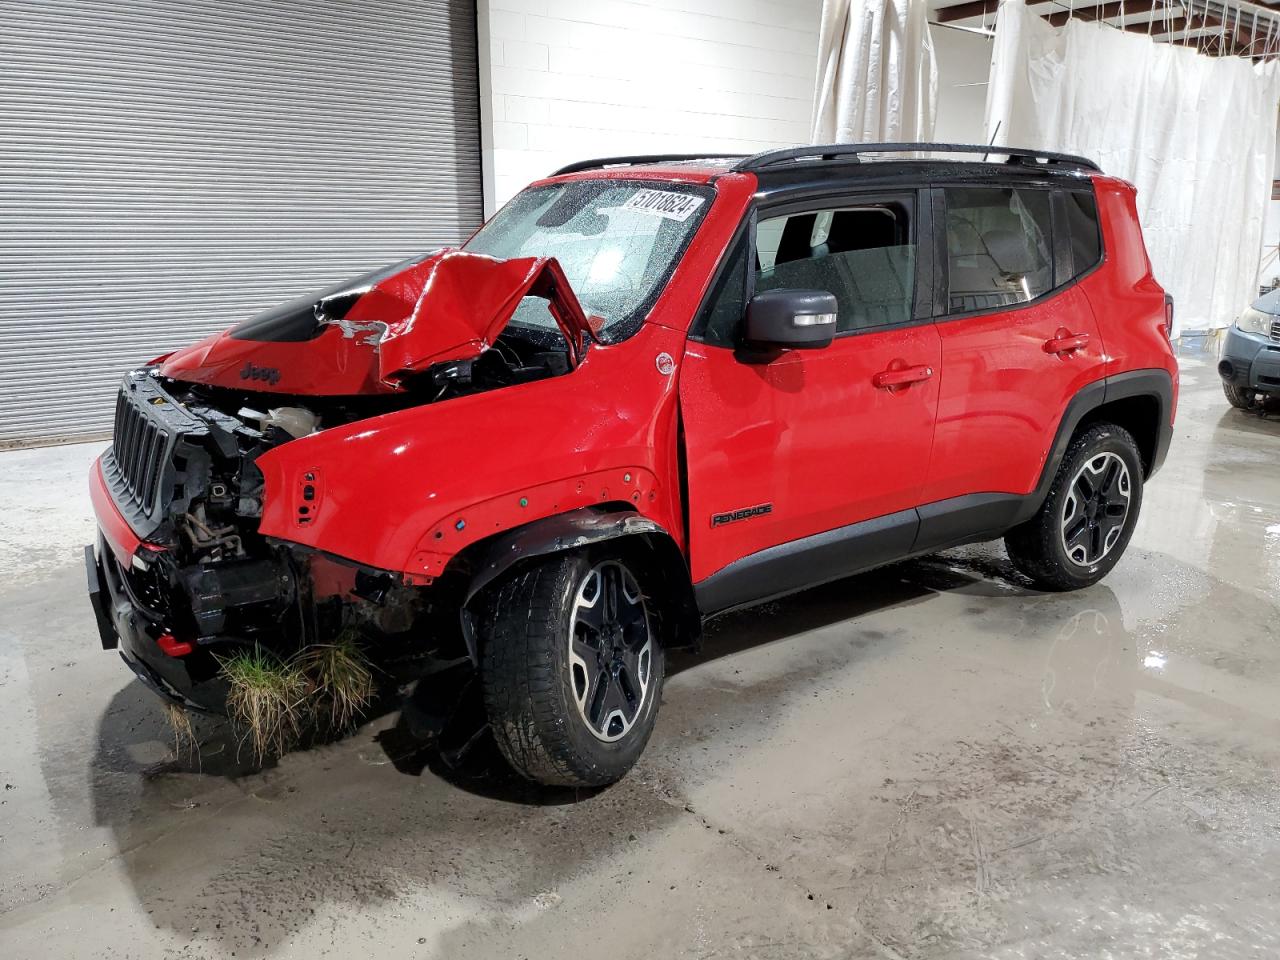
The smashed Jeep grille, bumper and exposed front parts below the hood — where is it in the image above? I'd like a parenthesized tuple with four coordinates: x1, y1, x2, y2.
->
(88, 358, 460, 713)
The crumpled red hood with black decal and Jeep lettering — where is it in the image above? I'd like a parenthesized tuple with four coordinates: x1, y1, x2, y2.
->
(160, 250, 590, 396)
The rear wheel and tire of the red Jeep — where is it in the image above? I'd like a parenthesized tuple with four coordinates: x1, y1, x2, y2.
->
(1005, 424, 1142, 590)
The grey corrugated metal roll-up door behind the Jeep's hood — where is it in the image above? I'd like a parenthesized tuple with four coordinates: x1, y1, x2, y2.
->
(0, 0, 481, 445)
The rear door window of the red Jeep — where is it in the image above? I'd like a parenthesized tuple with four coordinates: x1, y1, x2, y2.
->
(946, 187, 1053, 314)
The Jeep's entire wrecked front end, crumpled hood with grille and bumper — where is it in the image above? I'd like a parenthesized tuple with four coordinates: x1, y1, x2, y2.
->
(87, 251, 589, 727)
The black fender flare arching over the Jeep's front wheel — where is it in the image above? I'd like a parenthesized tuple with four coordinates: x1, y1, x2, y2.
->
(449, 507, 701, 666)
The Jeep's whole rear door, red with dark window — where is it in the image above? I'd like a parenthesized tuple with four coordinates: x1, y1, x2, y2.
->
(922, 186, 1106, 524)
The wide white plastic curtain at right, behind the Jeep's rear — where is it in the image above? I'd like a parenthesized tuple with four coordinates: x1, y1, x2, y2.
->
(986, 0, 1280, 335)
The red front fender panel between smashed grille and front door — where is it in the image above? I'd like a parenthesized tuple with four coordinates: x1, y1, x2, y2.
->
(257, 325, 682, 576)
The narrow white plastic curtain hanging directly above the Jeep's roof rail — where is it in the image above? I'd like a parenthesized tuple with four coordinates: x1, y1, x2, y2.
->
(812, 0, 938, 143)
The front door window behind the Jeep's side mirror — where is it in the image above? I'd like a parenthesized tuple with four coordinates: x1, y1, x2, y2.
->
(755, 204, 915, 333)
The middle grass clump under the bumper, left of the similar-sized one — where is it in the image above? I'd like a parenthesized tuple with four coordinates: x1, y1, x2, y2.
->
(218, 645, 307, 763)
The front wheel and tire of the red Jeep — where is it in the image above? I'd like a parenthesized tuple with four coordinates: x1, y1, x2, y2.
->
(480, 550, 664, 787)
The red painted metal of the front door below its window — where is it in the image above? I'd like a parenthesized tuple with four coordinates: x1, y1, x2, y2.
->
(681, 324, 940, 581)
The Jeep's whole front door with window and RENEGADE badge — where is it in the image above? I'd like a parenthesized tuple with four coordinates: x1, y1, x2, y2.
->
(680, 193, 941, 609)
